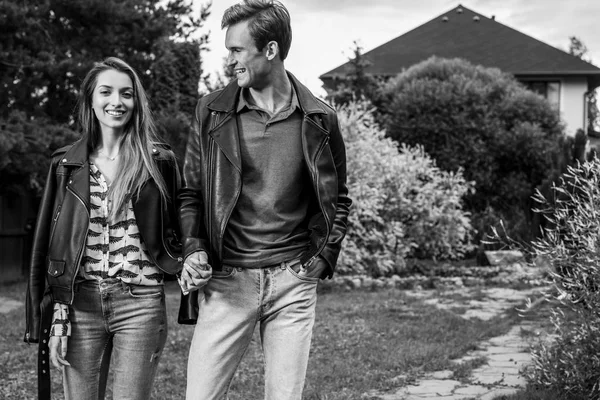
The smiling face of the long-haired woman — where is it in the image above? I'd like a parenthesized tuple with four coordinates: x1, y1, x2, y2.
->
(92, 69, 135, 134)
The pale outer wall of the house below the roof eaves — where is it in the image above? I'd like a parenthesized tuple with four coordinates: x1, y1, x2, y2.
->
(560, 77, 588, 136)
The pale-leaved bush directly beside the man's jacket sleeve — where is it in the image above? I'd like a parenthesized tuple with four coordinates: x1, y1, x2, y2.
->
(338, 101, 473, 276)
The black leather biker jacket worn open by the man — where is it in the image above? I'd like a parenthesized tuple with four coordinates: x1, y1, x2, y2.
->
(179, 73, 352, 323)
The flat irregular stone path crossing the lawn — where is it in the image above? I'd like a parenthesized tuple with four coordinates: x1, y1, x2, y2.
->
(366, 288, 544, 400)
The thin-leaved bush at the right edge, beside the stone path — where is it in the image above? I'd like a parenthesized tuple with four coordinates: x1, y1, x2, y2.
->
(496, 159, 600, 399)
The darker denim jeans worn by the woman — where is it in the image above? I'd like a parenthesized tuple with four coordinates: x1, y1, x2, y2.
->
(63, 279, 167, 400)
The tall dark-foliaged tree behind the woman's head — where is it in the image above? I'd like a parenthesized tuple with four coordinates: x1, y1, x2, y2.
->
(0, 0, 210, 192)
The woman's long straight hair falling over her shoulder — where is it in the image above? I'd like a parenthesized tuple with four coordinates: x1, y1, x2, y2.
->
(77, 57, 169, 221)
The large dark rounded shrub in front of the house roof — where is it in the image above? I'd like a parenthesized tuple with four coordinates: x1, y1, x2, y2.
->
(382, 57, 563, 239)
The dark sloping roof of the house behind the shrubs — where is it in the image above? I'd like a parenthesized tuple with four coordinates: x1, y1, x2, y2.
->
(319, 5, 600, 86)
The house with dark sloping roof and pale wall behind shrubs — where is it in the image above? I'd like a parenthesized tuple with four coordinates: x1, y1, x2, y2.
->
(319, 5, 600, 135)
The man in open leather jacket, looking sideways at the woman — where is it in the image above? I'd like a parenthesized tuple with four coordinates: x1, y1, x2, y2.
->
(179, 0, 351, 400)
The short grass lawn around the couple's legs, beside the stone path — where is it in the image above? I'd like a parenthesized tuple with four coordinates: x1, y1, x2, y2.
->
(0, 282, 517, 400)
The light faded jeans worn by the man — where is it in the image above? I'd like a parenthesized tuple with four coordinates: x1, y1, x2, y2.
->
(186, 260, 319, 400)
